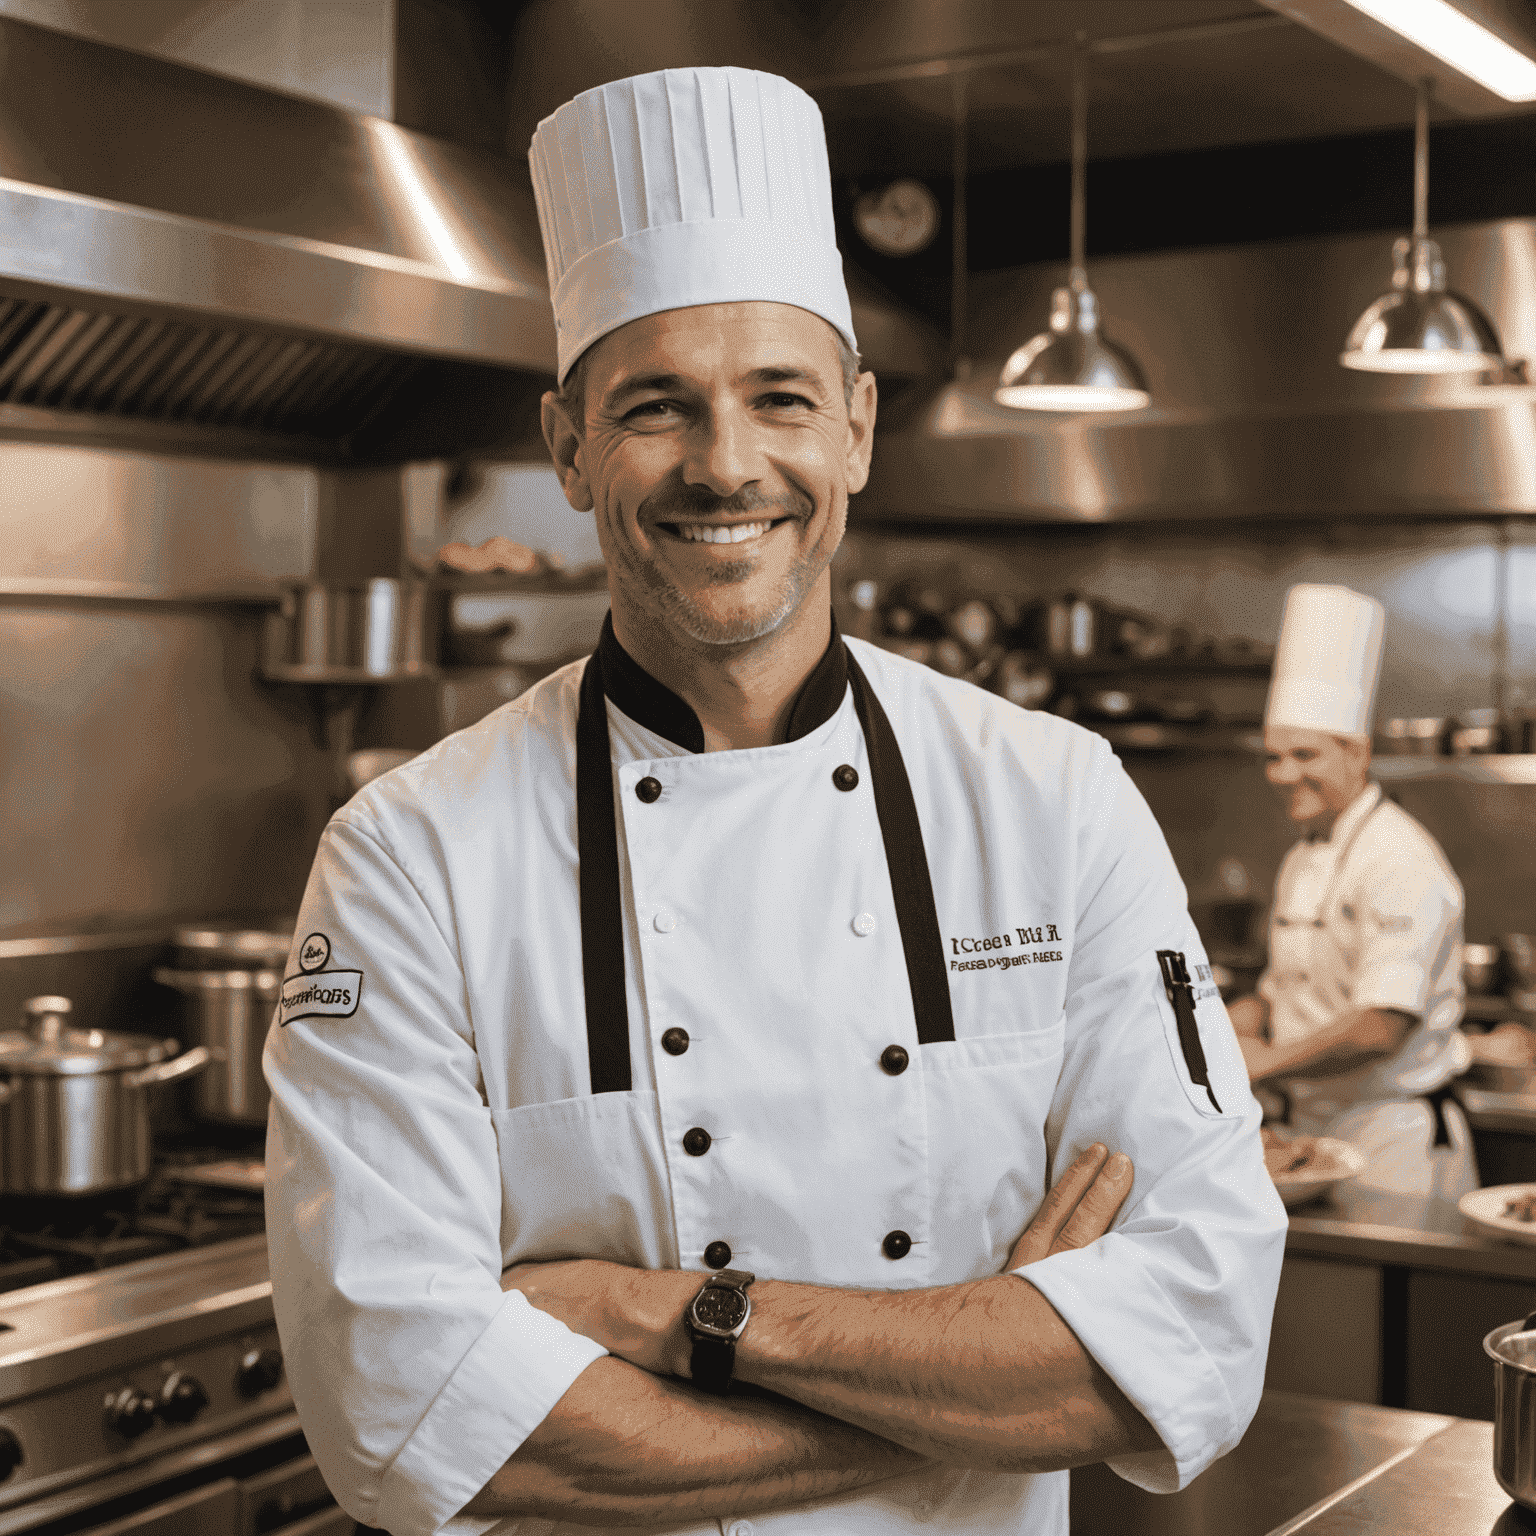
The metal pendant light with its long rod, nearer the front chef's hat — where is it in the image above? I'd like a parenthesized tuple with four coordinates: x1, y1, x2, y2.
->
(992, 32, 1150, 410)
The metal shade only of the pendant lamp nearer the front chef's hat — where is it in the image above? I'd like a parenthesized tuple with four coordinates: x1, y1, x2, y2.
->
(992, 286, 1150, 412)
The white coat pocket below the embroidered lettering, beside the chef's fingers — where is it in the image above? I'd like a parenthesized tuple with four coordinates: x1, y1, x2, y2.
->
(919, 1014, 1066, 1286)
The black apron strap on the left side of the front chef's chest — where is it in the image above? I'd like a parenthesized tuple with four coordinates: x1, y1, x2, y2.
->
(576, 653, 631, 1094)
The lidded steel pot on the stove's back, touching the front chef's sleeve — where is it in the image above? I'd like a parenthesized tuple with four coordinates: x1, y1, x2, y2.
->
(154, 925, 293, 1126)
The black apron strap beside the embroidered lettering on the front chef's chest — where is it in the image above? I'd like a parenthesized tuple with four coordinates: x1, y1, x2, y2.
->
(848, 651, 955, 1046)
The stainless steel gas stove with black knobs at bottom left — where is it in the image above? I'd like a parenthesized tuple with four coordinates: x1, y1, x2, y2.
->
(0, 1146, 336, 1536)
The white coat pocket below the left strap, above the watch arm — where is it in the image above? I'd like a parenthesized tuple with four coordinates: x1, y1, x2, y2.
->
(492, 1092, 677, 1269)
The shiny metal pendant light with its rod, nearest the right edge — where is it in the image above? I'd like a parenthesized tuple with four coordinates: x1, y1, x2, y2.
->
(1339, 80, 1504, 373)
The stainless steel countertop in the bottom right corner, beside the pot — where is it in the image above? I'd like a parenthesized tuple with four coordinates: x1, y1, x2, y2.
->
(1072, 1392, 1505, 1536)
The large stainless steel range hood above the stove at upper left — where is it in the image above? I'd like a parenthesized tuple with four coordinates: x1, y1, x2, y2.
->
(0, 20, 554, 456)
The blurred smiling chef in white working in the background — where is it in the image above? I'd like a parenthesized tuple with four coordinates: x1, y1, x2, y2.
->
(1232, 585, 1478, 1215)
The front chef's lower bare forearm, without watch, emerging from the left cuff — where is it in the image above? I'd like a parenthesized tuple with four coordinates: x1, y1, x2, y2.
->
(467, 1358, 925, 1527)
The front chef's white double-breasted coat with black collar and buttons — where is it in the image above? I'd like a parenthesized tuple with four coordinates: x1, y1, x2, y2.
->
(266, 630, 1284, 1536)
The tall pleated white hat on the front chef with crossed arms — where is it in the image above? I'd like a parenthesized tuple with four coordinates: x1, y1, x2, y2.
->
(528, 69, 859, 384)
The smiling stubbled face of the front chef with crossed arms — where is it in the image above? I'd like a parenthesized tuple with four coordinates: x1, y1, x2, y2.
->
(544, 303, 876, 647)
